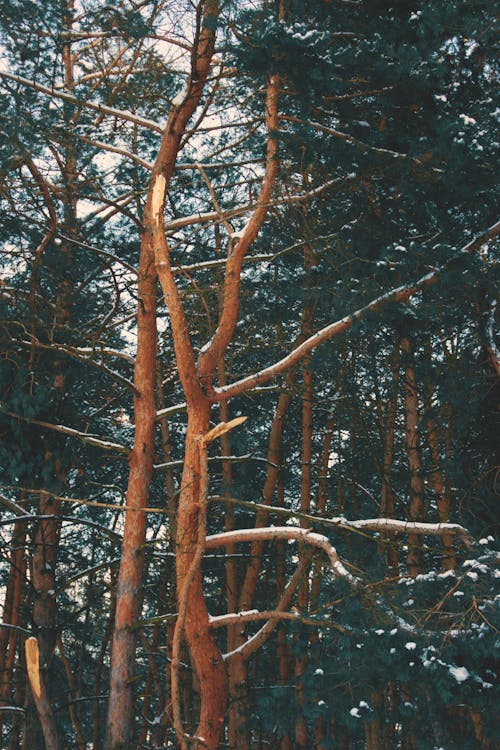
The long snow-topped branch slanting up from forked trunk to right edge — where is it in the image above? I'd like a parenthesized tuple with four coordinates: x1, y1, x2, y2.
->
(211, 221, 500, 401)
